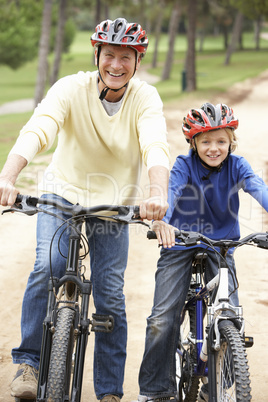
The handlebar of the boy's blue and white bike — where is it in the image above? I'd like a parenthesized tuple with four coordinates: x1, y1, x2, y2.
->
(147, 230, 268, 249)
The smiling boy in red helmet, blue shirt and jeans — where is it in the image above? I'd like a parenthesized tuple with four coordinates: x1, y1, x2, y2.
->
(138, 103, 268, 402)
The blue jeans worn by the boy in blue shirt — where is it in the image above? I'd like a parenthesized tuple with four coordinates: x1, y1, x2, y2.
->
(139, 248, 238, 398)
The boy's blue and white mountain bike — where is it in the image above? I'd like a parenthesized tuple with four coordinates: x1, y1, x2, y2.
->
(147, 230, 268, 402)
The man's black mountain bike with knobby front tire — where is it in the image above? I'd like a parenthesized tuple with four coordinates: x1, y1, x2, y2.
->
(3, 195, 148, 402)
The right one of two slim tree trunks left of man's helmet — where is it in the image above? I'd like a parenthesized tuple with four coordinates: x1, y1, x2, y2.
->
(50, 0, 68, 86)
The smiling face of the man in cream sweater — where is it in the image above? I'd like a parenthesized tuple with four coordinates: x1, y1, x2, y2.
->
(95, 45, 140, 96)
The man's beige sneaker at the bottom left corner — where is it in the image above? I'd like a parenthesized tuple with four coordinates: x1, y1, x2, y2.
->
(11, 363, 38, 399)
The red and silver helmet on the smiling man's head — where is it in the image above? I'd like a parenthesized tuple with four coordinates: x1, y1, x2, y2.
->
(91, 18, 149, 54)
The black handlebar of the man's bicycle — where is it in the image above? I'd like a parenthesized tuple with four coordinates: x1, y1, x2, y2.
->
(2, 194, 149, 226)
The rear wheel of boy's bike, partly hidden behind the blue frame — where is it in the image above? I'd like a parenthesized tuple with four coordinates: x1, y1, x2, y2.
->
(176, 290, 200, 402)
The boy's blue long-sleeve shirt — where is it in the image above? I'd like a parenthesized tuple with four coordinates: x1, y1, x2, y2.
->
(164, 149, 268, 248)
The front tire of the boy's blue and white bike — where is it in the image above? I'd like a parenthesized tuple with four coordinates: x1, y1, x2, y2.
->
(215, 321, 251, 402)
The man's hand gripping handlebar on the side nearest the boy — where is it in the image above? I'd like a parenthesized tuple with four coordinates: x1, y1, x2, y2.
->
(140, 196, 168, 221)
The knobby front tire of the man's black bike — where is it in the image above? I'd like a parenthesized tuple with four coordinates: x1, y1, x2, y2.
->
(46, 307, 75, 402)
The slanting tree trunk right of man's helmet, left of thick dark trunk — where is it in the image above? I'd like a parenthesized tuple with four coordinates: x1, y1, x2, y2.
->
(162, 0, 181, 81)
